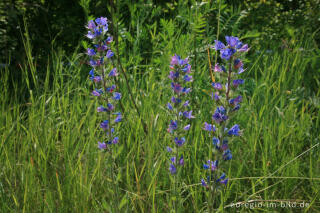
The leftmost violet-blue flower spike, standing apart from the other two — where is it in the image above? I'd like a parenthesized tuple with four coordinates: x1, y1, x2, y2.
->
(86, 17, 122, 150)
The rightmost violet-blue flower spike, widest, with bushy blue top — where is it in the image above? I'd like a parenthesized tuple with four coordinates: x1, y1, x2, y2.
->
(201, 36, 249, 188)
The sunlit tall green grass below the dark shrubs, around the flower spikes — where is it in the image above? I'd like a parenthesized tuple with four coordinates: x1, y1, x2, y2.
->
(0, 0, 320, 212)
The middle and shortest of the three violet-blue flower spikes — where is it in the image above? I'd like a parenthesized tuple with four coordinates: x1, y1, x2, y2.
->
(167, 55, 194, 174)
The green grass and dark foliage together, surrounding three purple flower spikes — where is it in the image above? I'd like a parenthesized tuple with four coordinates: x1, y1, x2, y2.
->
(0, 0, 320, 212)
